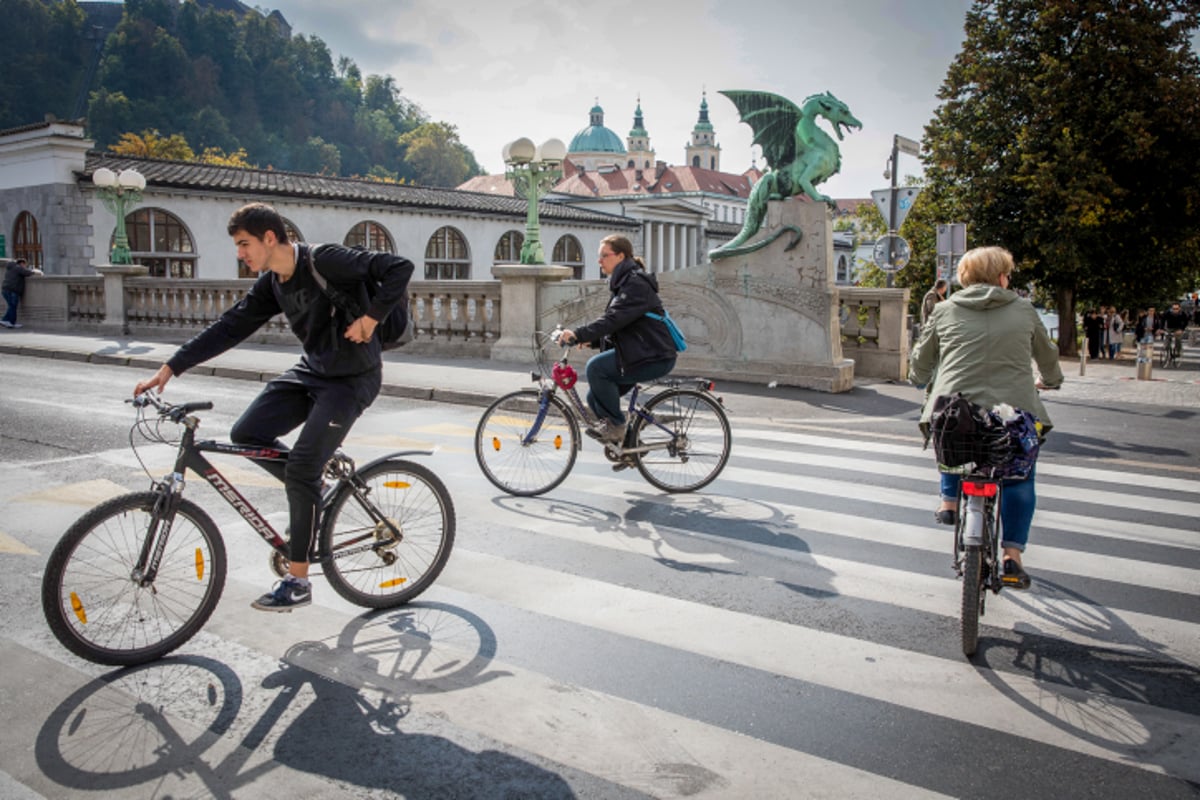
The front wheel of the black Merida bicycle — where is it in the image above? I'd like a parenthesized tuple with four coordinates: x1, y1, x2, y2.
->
(42, 492, 226, 667)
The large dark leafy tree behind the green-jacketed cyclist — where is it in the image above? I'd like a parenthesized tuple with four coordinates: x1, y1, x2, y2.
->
(924, 0, 1200, 355)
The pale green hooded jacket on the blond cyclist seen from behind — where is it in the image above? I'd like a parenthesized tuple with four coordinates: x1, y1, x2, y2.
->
(908, 283, 1062, 429)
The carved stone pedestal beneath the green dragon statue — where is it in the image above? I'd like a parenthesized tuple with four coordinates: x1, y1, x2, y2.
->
(659, 198, 854, 392)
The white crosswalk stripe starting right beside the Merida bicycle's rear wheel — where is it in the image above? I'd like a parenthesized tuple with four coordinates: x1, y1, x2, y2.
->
(445, 551, 1200, 780)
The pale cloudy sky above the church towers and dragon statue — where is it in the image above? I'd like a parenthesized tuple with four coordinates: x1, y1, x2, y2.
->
(259, 0, 971, 198)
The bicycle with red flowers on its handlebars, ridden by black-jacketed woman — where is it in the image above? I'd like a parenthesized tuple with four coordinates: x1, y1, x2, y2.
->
(475, 330, 732, 497)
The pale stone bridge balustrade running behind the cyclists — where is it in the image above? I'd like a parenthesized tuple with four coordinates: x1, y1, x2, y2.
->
(20, 266, 908, 380)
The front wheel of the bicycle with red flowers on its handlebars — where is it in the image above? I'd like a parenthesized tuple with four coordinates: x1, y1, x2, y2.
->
(475, 389, 580, 497)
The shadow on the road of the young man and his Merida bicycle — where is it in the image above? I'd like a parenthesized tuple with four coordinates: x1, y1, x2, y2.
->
(35, 602, 575, 798)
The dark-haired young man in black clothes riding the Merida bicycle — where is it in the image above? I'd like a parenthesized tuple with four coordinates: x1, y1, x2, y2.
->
(133, 203, 413, 612)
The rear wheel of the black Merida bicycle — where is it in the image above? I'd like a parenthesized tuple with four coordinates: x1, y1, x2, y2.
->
(320, 459, 455, 608)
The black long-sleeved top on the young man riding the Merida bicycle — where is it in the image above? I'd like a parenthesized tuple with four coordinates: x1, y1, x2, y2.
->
(167, 245, 413, 378)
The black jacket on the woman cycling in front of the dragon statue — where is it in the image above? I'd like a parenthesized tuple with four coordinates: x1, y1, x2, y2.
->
(575, 258, 676, 374)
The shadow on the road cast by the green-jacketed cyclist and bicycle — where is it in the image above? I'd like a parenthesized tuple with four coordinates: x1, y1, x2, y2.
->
(973, 579, 1200, 783)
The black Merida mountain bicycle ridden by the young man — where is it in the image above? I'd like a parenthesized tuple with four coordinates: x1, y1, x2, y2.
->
(42, 392, 455, 666)
